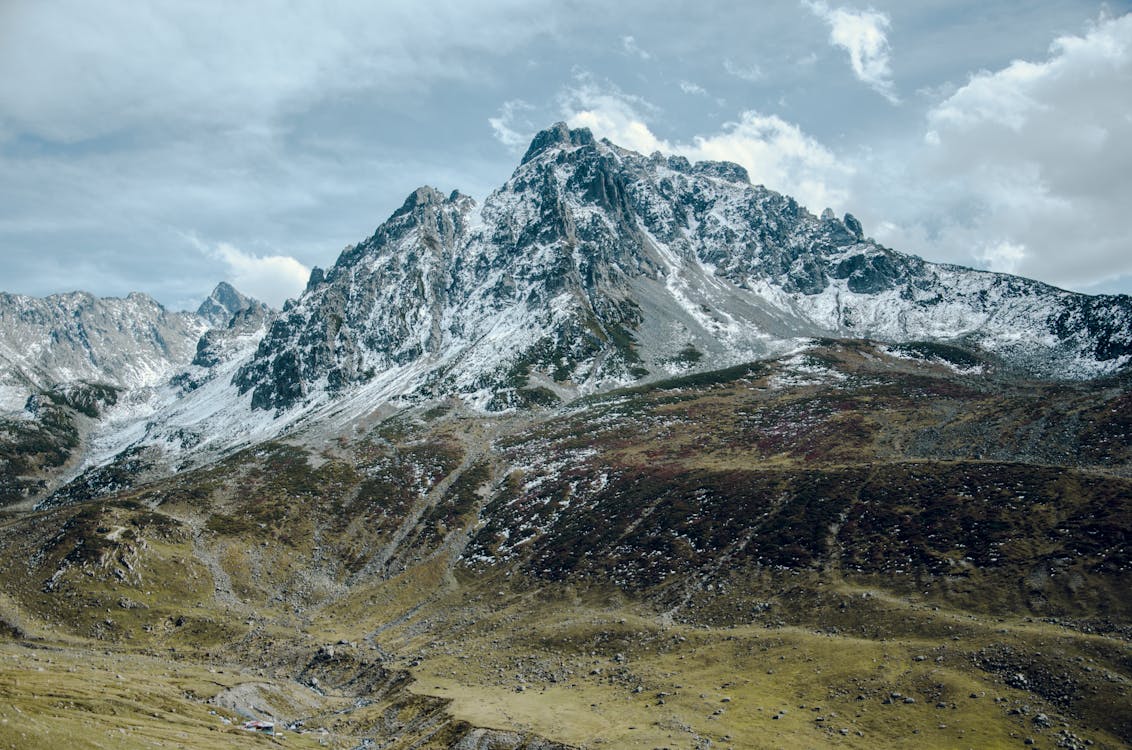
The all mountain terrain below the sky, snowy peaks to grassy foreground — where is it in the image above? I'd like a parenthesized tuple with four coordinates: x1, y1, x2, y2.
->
(0, 124, 1132, 750)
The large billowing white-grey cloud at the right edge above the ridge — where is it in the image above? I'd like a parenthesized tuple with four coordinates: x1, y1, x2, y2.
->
(859, 15, 1132, 288)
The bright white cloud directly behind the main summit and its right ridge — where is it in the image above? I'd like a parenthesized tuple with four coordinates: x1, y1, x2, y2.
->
(561, 79, 852, 212)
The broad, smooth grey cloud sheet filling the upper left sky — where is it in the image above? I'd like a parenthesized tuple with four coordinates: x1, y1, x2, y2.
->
(0, 0, 560, 143)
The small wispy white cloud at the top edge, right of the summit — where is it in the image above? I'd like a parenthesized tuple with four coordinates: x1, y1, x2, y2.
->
(805, 0, 899, 104)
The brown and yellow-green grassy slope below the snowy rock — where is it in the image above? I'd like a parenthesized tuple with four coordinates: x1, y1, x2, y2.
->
(0, 344, 1132, 748)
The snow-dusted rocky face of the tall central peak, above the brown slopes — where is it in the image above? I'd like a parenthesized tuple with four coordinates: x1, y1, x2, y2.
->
(233, 123, 1132, 413)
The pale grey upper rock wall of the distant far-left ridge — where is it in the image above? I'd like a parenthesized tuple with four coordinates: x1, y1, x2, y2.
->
(0, 292, 207, 412)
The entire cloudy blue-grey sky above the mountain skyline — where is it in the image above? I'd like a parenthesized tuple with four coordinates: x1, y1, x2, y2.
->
(0, 0, 1132, 309)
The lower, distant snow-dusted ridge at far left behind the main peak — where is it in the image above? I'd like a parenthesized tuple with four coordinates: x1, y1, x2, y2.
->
(0, 283, 259, 507)
